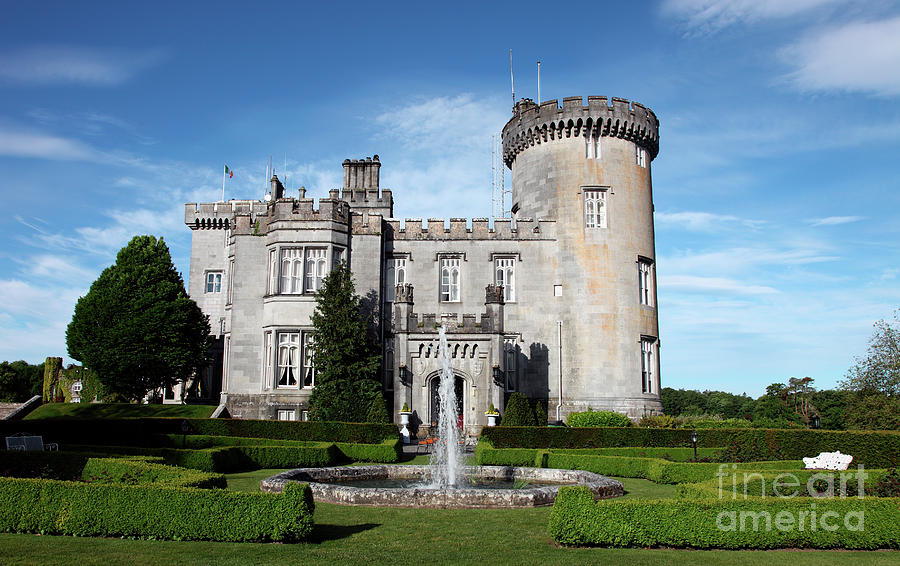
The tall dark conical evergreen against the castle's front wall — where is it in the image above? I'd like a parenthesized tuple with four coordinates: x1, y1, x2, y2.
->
(309, 264, 381, 422)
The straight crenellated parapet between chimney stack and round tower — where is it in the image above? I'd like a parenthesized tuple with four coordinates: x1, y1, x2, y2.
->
(385, 218, 556, 240)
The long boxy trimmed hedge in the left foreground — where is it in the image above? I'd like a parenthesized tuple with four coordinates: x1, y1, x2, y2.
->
(0, 478, 314, 542)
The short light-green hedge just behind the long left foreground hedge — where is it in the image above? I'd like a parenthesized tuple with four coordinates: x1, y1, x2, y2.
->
(81, 458, 226, 489)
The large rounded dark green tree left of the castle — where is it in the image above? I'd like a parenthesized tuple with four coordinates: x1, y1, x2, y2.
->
(66, 236, 209, 399)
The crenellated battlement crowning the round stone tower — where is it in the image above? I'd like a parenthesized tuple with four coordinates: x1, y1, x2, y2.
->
(503, 96, 659, 167)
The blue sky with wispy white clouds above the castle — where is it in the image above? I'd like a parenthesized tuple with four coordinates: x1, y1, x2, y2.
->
(0, 0, 900, 396)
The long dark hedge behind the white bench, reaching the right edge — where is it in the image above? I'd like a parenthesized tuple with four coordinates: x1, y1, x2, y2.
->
(481, 427, 900, 468)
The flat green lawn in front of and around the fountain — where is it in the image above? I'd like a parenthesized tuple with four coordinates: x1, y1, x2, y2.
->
(0, 466, 900, 566)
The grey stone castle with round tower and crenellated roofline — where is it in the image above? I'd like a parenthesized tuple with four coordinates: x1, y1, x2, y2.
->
(185, 96, 662, 429)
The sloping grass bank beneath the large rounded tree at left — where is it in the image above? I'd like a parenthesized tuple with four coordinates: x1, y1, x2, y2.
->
(24, 403, 216, 420)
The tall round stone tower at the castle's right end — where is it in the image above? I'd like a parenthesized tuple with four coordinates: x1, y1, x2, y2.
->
(503, 96, 662, 418)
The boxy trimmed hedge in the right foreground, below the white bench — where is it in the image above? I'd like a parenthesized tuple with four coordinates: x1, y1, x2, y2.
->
(548, 486, 900, 549)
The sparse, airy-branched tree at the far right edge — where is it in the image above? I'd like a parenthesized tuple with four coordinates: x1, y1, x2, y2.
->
(840, 310, 900, 396)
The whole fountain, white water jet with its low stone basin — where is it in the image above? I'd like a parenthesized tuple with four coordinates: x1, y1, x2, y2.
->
(260, 325, 624, 508)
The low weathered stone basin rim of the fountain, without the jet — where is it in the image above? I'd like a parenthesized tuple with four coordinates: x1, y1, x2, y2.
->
(261, 465, 625, 508)
